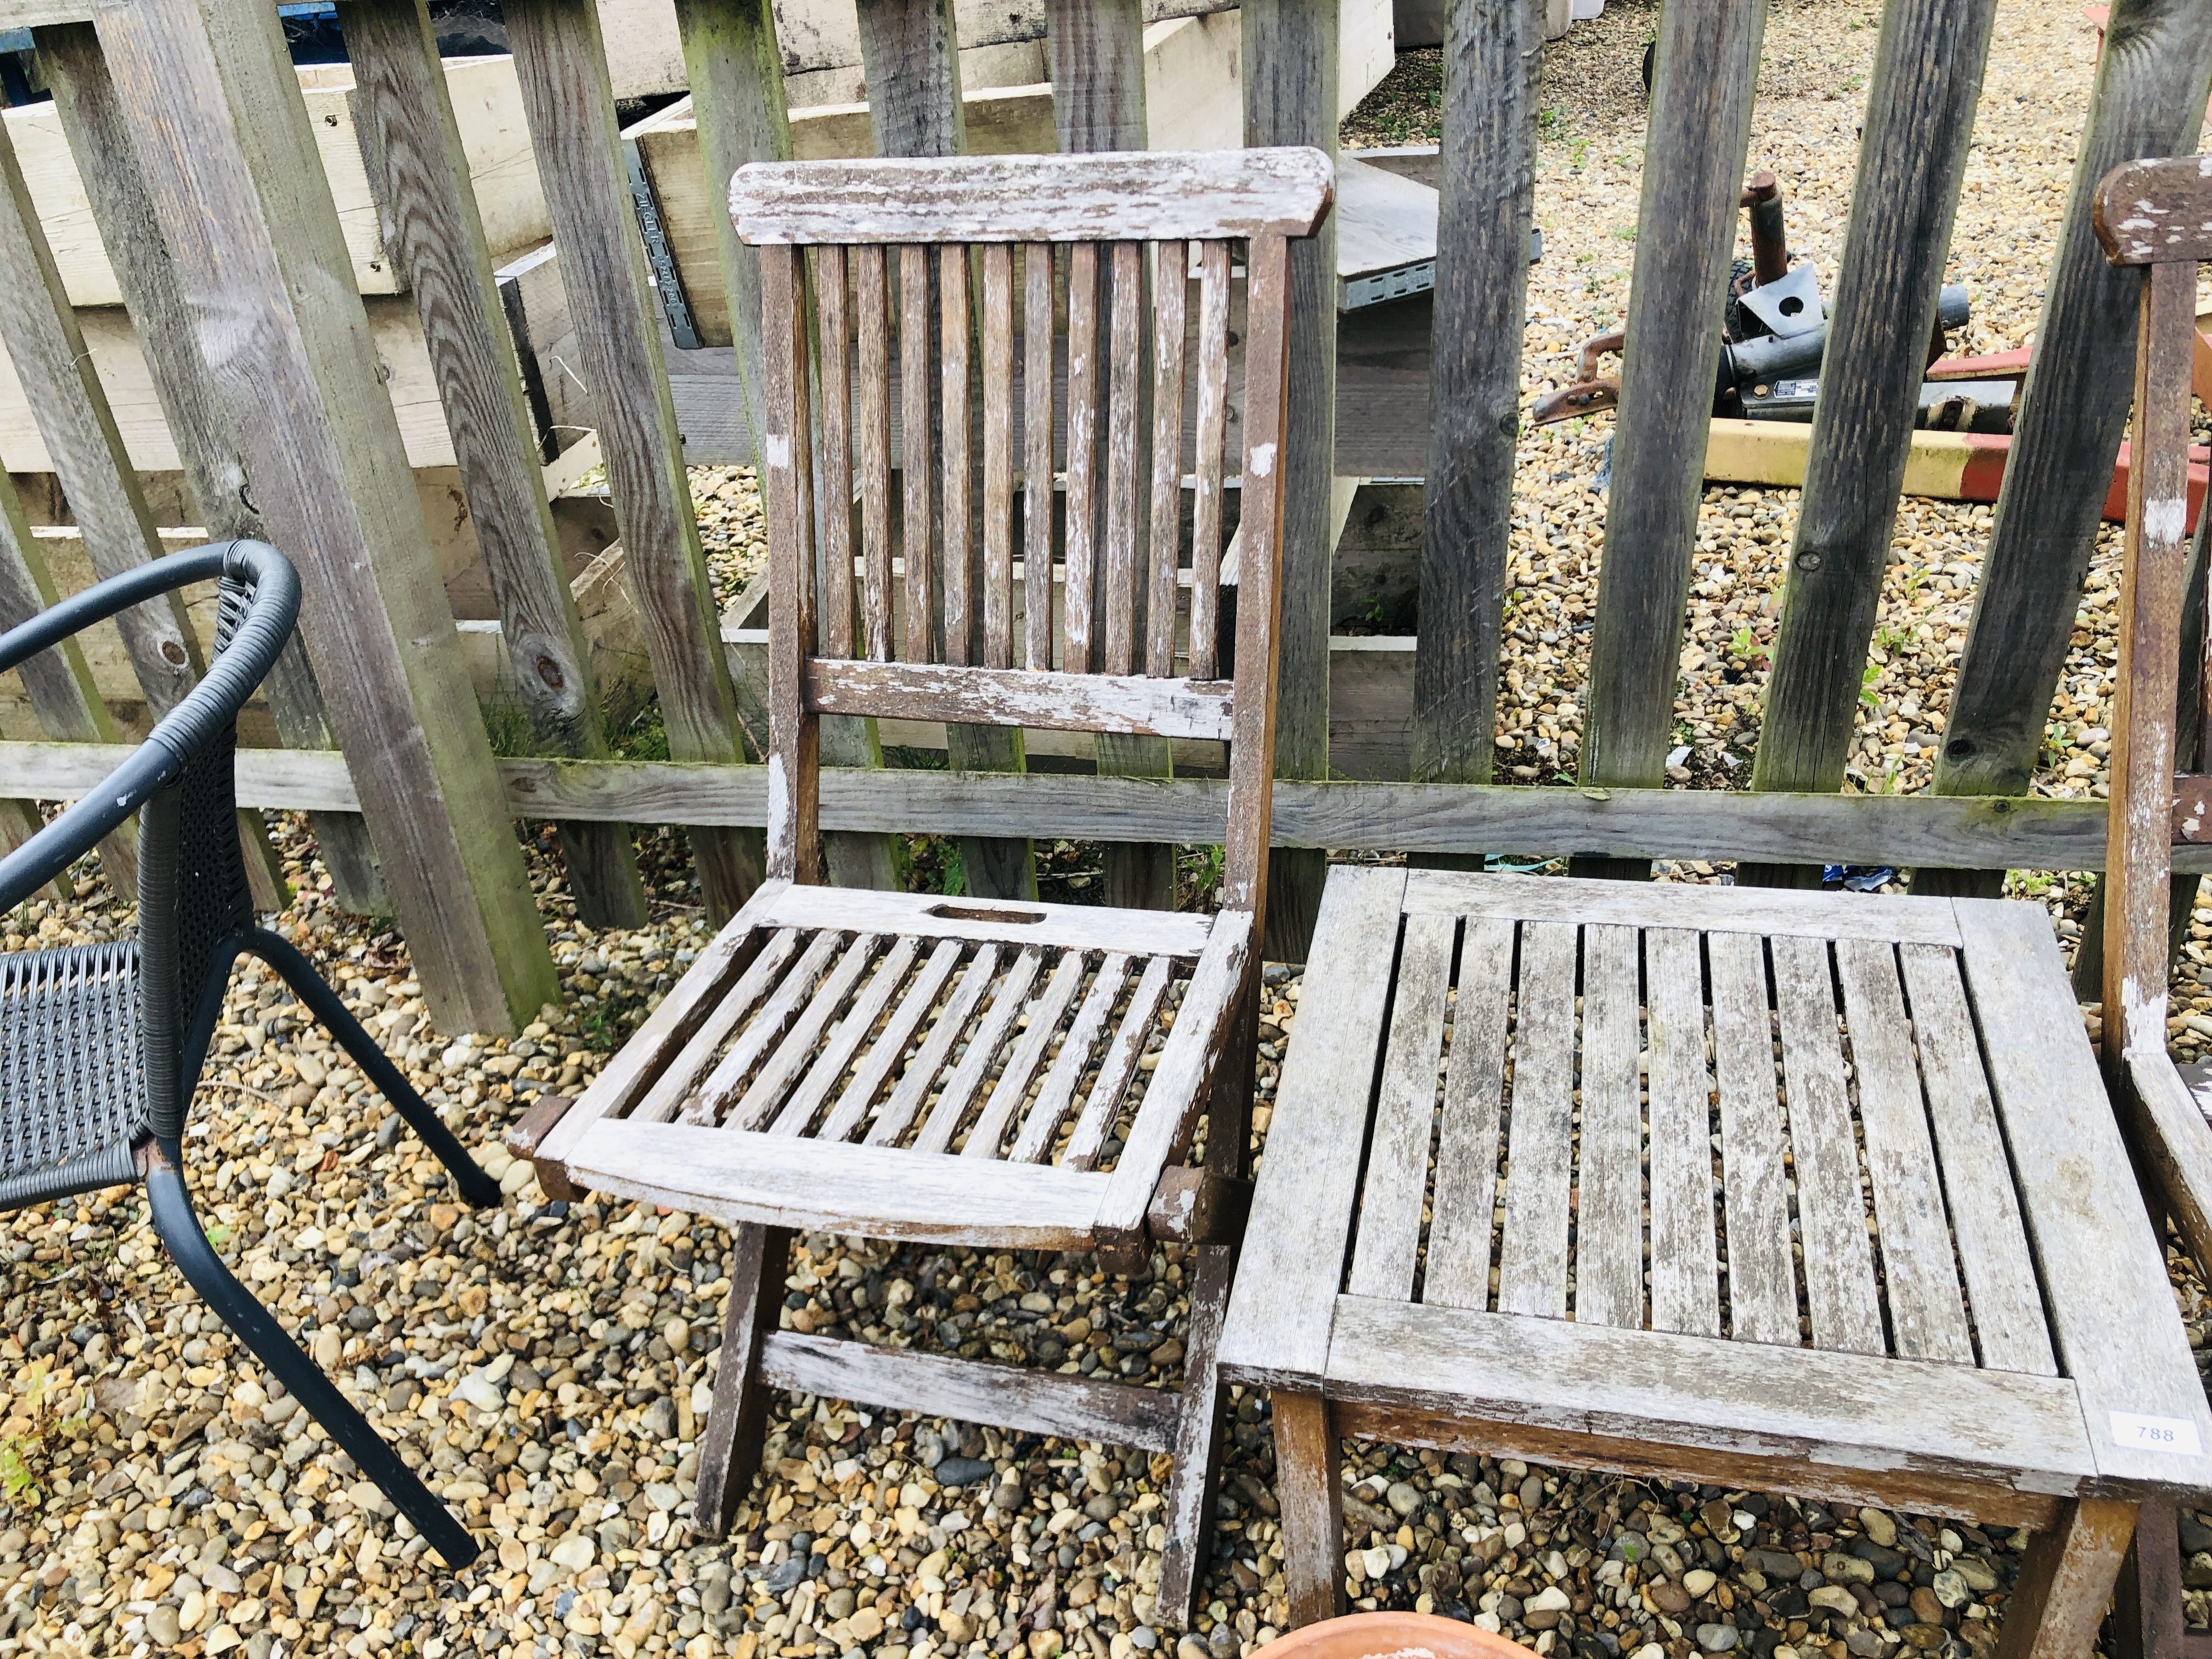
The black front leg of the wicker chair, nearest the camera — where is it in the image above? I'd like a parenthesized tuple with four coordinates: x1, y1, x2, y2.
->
(139, 1142, 480, 1573)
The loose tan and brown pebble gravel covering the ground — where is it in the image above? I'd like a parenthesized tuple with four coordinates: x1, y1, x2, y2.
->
(0, 0, 2212, 1659)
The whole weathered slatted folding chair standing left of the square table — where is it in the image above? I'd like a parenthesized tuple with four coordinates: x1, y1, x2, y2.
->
(520, 150, 1331, 1619)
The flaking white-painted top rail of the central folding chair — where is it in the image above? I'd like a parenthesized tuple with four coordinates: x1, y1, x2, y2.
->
(730, 146, 1336, 246)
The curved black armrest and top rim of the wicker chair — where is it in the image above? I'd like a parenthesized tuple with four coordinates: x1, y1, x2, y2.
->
(0, 542, 298, 911)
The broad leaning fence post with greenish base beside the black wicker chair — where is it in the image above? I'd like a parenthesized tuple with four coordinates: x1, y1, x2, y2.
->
(95, 0, 560, 1031)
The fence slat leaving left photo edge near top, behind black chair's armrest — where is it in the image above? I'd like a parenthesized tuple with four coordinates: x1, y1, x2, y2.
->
(0, 104, 292, 909)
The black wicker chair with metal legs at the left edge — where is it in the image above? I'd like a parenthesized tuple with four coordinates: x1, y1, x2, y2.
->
(0, 542, 500, 1568)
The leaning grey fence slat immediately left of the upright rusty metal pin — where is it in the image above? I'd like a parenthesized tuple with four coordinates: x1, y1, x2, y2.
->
(1575, 0, 1768, 876)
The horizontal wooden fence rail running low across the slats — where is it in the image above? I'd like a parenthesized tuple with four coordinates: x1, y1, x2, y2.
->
(0, 743, 2176, 874)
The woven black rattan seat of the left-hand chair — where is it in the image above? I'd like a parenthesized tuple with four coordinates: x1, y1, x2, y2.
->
(0, 940, 148, 1210)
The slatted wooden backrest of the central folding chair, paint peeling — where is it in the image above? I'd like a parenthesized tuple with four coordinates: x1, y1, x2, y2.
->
(730, 150, 1329, 909)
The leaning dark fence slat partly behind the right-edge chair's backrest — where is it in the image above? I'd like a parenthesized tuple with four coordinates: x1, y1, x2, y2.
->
(1914, 0, 2212, 898)
